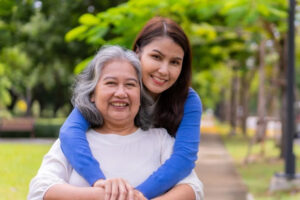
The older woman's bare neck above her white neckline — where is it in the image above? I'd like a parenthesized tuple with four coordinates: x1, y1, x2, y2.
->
(95, 122, 138, 135)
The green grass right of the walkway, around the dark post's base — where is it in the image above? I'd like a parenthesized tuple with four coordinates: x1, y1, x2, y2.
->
(223, 136, 300, 200)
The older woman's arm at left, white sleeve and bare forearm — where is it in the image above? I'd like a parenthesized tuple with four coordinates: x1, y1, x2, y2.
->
(28, 140, 105, 200)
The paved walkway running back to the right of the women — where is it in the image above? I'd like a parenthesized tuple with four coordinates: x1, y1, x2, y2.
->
(196, 134, 247, 200)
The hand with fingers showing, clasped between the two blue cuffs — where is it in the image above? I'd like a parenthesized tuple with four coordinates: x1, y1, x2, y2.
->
(93, 178, 135, 200)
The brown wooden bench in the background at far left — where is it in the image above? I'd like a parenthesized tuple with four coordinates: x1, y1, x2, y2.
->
(0, 118, 35, 137)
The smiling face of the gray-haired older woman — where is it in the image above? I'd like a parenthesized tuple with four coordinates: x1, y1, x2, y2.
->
(91, 60, 140, 125)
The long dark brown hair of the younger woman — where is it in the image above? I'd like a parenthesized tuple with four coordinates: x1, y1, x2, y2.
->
(133, 17, 192, 136)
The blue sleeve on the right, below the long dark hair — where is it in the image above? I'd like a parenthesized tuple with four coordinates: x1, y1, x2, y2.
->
(136, 88, 202, 198)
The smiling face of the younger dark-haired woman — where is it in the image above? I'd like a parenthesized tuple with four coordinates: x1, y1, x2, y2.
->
(138, 37, 184, 98)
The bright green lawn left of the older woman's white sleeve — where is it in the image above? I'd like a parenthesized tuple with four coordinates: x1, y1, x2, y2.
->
(0, 143, 51, 200)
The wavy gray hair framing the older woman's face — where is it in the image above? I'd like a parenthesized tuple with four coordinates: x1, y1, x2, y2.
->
(72, 46, 152, 130)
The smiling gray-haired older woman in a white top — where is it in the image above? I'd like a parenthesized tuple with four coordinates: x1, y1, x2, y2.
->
(28, 46, 203, 200)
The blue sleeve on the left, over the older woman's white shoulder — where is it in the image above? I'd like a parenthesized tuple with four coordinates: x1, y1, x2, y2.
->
(59, 108, 105, 186)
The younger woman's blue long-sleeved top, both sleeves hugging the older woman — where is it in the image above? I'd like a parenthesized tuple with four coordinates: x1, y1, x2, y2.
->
(59, 88, 202, 199)
